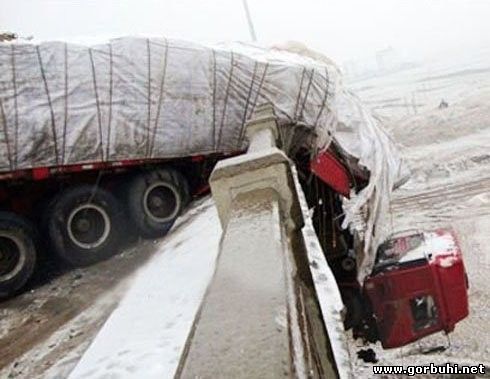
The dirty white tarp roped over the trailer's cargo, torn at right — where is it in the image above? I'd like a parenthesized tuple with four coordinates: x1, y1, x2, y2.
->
(0, 38, 403, 279)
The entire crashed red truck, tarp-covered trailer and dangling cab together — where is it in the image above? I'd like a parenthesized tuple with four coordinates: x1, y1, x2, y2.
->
(0, 37, 468, 348)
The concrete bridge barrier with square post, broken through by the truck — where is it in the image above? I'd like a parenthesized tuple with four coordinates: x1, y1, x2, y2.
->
(176, 104, 350, 378)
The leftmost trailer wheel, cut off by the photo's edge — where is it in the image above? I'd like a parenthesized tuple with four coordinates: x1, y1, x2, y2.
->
(0, 212, 36, 299)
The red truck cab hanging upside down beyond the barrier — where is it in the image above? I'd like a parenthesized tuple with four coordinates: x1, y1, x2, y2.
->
(364, 230, 468, 348)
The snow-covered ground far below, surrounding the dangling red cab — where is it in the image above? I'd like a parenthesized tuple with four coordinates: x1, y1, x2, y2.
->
(351, 51, 490, 378)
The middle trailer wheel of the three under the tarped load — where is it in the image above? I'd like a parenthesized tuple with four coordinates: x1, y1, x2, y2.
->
(48, 185, 122, 267)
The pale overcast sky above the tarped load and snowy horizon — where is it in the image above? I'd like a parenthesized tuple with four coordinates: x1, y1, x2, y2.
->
(0, 0, 490, 63)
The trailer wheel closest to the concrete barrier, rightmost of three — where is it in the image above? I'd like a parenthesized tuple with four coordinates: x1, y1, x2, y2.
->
(126, 169, 188, 238)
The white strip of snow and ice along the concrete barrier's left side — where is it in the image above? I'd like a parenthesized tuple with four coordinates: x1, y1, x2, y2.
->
(69, 199, 221, 379)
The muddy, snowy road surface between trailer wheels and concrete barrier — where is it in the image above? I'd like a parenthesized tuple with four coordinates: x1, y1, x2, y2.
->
(0, 197, 221, 379)
